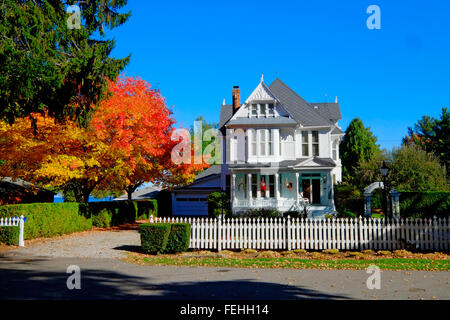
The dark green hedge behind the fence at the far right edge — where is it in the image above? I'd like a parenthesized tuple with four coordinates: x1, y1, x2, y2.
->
(400, 191, 450, 218)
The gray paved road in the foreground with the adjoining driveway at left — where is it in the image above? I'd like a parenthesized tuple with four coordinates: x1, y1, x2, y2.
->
(0, 231, 450, 300)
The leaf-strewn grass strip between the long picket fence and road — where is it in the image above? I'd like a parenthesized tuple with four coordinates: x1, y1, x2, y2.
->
(126, 254, 450, 271)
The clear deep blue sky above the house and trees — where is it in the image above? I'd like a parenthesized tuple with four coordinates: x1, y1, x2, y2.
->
(103, 0, 450, 149)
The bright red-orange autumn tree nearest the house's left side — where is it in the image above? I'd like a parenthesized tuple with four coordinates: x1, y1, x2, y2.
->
(91, 77, 207, 199)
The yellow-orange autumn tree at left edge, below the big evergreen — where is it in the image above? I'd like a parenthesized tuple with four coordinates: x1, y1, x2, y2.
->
(0, 114, 121, 202)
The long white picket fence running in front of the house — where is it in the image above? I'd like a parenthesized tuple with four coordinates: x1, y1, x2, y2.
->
(150, 217, 450, 251)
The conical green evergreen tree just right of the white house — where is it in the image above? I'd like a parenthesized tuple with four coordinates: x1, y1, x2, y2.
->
(339, 118, 381, 182)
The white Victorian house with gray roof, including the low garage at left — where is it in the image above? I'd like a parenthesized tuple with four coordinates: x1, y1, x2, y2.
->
(172, 79, 344, 217)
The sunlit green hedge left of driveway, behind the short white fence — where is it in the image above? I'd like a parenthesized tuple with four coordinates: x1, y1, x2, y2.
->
(0, 203, 92, 239)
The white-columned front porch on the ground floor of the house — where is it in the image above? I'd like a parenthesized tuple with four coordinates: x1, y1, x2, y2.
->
(231, 170, 334, 217)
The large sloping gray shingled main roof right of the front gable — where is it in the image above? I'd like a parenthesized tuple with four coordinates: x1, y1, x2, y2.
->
(269, 78, 331, 126)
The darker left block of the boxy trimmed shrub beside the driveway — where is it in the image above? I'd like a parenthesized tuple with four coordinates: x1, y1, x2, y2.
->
(139, 223, 171, 253)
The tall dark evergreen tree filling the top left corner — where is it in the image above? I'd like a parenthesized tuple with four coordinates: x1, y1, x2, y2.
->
(0, 0, 130, 125)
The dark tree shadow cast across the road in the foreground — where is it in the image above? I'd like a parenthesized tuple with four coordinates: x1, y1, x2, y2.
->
(0, 260, 347, 300)
